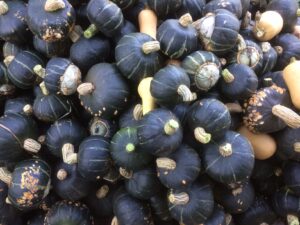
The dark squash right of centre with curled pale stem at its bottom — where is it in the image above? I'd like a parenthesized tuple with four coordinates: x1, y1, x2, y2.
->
(188, 98, 231, 144)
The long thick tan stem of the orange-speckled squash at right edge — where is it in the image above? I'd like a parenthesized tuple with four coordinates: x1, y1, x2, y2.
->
(272, 105, 300, 129)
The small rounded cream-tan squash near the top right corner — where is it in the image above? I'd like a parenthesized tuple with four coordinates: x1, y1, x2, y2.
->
(253, 11, 283, 41)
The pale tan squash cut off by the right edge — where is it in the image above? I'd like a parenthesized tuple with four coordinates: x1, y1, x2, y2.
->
(283, 58, 300, 109)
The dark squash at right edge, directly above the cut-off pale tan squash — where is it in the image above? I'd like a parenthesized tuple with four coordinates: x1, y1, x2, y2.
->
(273, 33, 300, 70)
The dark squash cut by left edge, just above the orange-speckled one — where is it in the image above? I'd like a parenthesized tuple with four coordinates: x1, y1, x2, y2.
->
(0, 113, 41, 163)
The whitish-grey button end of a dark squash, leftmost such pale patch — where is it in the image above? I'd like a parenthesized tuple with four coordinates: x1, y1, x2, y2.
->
(60, 64, 81, 95)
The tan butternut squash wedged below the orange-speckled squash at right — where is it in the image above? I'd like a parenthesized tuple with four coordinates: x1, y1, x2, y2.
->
(238, 126, 276, 160)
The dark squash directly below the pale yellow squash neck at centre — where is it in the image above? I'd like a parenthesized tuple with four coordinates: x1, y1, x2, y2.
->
(137, 109, 182, 156)
